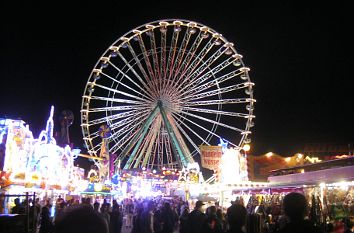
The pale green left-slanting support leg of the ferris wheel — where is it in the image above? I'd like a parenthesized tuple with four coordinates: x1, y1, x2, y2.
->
(122, 106, 159, 169)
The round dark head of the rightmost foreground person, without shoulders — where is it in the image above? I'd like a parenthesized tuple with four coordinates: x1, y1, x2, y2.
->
(283, 193, 307, 222)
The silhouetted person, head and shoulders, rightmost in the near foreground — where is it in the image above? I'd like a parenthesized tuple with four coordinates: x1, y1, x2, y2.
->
(278, 192, 323, 233)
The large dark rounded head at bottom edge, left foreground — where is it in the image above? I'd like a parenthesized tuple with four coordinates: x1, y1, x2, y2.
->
(55, 205, 109, 233)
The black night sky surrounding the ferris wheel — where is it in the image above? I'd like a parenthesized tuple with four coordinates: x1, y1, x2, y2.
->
(0, 1, 354, 155)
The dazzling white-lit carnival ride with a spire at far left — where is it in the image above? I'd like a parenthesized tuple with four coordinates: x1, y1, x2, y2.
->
(0, 106, 84, 193)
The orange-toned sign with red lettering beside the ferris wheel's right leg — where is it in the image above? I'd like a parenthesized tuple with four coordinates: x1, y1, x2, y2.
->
(200, 145, 222, 170)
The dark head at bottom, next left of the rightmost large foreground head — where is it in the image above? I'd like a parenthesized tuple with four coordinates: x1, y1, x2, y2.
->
(227, 204, 247, 229)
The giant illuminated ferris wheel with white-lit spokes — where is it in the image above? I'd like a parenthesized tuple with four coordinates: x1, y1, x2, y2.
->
(81, 19, 256, 169)
